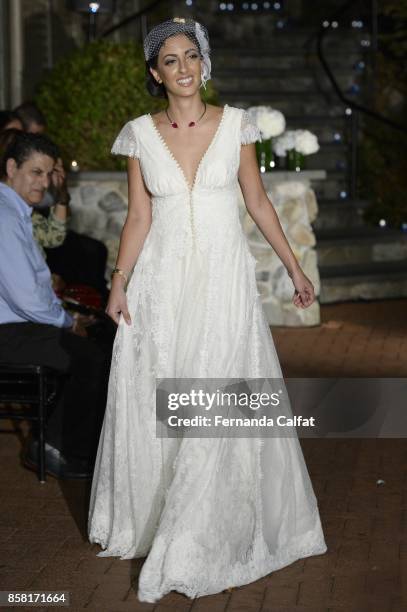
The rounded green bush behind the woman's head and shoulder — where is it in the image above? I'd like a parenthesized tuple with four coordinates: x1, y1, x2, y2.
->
(36, 40, 217, 170)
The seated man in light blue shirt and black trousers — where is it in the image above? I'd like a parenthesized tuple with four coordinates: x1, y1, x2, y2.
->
(0, 133, 111, 478)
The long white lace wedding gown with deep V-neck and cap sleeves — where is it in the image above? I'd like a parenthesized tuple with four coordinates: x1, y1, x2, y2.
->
(89, 105, 327, 602)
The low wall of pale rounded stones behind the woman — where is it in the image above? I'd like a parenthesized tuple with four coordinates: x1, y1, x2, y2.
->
(69, 172, 321, 326)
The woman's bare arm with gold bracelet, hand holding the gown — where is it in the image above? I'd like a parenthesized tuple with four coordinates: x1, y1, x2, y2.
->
(106, 158, 151, 325)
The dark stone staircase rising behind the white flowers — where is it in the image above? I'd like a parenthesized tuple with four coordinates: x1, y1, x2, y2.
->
(209, 13, 407, 303)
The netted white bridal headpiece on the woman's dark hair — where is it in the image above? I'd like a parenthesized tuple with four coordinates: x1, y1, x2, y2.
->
(143, 17, 211, 88)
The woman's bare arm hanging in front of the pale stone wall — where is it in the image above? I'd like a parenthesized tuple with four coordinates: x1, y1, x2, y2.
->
(238, 144, 315, 308)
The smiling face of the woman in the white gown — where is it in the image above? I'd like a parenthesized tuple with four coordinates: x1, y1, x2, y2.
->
(150, 34, 201, 96)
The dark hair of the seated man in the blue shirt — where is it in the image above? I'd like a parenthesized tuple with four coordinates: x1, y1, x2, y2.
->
(0, 130, 60, 178)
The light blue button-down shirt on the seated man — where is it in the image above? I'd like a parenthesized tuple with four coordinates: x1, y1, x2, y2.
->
(0, 182, 73, 327)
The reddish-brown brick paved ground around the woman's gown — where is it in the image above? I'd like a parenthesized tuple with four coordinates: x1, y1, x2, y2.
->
(0, 300, 407, 612)
